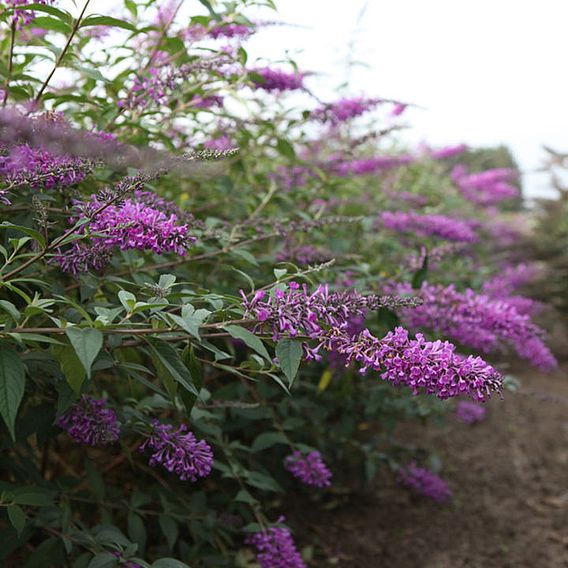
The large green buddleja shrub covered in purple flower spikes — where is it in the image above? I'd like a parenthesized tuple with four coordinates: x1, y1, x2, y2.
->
(0, 0, 555, 568)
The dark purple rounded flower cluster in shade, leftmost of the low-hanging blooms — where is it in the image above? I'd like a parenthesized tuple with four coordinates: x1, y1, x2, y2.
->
(55, 395, 120, 446)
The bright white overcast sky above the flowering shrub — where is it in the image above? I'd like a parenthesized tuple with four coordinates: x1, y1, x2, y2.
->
(62, 0, 568, 197)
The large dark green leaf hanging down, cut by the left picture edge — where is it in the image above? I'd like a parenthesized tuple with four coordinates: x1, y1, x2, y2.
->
(0, 343, 26, 441)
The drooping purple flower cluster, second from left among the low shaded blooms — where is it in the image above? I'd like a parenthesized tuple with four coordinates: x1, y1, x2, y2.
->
(140, 420, 213, 481)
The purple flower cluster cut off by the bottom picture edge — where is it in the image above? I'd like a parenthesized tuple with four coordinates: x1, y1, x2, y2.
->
(245, 517, 306, 568)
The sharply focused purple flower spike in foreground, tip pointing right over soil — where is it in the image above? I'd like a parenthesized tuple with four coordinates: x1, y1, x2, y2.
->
(324, 327, 503, 401)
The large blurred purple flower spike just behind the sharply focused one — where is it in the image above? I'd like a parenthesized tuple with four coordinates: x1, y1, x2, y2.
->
(395, 282, 557, 370)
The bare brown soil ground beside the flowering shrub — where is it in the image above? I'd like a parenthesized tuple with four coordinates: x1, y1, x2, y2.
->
(289, 364, 568, 568)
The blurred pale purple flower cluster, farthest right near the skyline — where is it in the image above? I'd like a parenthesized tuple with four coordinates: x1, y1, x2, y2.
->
(452, 165, 519, 205)
